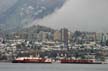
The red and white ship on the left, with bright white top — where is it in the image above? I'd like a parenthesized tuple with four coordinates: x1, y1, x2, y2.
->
(12, 57, 52, 63)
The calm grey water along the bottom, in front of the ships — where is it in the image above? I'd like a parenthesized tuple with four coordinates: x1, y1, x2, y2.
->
(0, 63, 108, 71)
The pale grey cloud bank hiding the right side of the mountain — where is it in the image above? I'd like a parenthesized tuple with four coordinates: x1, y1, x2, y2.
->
(35, 0, 108, 32)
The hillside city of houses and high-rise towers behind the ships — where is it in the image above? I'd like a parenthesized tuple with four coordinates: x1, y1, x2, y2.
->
(0, 25, 108, 64)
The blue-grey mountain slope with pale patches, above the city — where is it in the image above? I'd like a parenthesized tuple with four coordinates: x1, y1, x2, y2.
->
(0, 0, 65, 30)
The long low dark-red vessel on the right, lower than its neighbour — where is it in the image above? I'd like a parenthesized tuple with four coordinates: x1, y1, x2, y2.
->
(60, 59, 102, 64)
